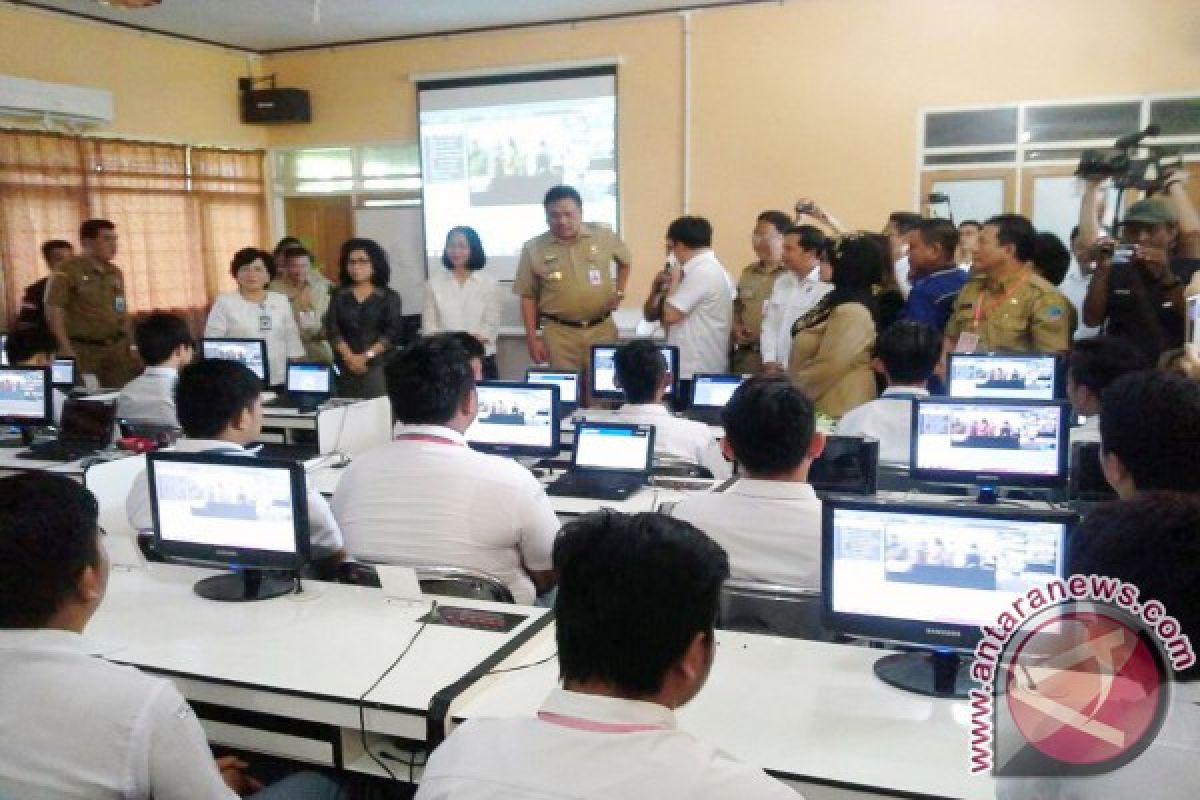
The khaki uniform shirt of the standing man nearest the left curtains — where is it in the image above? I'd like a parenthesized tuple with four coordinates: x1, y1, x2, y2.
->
(46, 255, 127, 343)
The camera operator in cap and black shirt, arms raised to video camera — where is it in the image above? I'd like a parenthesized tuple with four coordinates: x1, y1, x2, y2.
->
(1079, 170, 1200, 360)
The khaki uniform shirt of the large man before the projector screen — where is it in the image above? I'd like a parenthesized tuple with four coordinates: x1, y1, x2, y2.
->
(512, 223, 632, 321)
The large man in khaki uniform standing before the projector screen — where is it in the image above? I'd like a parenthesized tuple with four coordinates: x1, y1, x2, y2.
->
(512, 186, 630, 369)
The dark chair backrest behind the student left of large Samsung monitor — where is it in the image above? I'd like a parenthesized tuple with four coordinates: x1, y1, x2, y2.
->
(716, 581, 832, 642)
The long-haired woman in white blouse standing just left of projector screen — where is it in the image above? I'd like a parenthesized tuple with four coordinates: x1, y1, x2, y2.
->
(421, 225, 500, 380)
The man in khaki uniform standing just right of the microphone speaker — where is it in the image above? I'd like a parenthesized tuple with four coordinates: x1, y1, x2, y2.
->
(730, 211, 792, 374)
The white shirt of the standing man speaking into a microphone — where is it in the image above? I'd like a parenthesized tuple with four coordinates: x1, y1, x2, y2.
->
(667, 249, 736, 380)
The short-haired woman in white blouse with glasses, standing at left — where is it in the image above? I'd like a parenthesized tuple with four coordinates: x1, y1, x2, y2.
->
(204, 247, 304, 386)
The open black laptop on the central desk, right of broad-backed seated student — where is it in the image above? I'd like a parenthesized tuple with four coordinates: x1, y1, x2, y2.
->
(546, 422, 654, 500)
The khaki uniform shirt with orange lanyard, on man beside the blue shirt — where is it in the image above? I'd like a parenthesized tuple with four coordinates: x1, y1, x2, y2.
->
(946, 270, 1074, 353)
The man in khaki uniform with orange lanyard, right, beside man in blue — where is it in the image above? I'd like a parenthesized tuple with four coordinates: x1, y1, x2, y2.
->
(944, 213, 1074, 353)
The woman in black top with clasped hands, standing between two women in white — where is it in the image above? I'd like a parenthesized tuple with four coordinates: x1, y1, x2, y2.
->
(325, 239, 403, 397)
